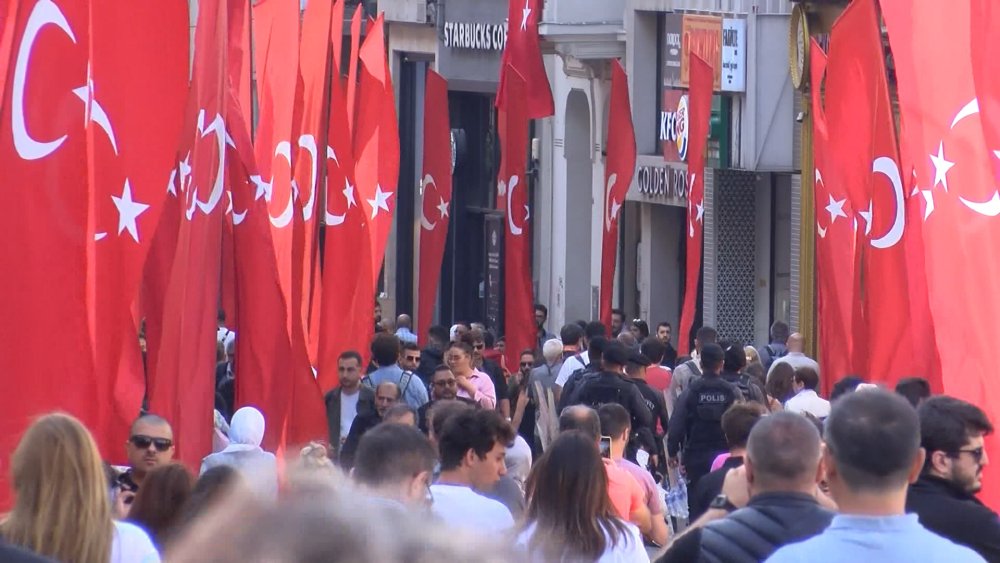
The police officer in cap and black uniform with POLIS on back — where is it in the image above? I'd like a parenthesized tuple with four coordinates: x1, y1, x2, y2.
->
(667, 344, 741, 488)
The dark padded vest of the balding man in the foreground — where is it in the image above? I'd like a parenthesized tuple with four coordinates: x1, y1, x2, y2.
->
(657, 493, 833, 563)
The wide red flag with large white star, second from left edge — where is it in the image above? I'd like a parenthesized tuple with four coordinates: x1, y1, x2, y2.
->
(89, 0, 189, 459)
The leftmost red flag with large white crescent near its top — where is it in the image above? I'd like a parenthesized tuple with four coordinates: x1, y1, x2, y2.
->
(0, 2, 93, 505)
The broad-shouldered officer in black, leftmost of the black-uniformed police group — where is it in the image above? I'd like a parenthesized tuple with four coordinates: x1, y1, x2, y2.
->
(568, 340, 653, 433)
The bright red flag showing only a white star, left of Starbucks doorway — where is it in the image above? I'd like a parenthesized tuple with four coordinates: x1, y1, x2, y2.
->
(348, 14, 399, 280)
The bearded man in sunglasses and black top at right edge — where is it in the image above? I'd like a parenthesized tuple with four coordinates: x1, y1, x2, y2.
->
(906, 396, 1000, 561)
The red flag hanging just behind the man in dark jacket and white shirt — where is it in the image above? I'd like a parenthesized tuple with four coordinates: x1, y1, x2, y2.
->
(319, 55, 375, 394)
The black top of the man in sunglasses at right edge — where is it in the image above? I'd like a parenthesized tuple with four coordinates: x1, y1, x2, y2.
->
(906, 475, 1000, 562)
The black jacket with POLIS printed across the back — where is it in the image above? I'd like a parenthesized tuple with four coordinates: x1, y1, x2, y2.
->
(667, 375, 742, 457)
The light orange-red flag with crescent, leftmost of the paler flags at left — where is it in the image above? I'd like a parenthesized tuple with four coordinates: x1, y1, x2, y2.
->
(253, 0, 301, 334)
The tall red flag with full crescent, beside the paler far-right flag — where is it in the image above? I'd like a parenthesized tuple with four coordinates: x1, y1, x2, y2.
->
(827, 0, 931, 385)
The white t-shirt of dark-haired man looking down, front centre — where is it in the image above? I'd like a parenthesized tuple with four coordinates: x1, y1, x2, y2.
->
(431, 484, 514, 535)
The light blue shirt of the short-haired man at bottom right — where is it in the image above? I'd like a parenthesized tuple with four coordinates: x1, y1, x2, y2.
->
(767, 514, 986, 563)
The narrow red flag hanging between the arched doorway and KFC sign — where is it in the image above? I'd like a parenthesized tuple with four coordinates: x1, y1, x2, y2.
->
(601, 60, 636, 334)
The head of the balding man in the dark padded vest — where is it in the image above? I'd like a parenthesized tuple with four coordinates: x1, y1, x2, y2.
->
(747, 412, 820, 493)
